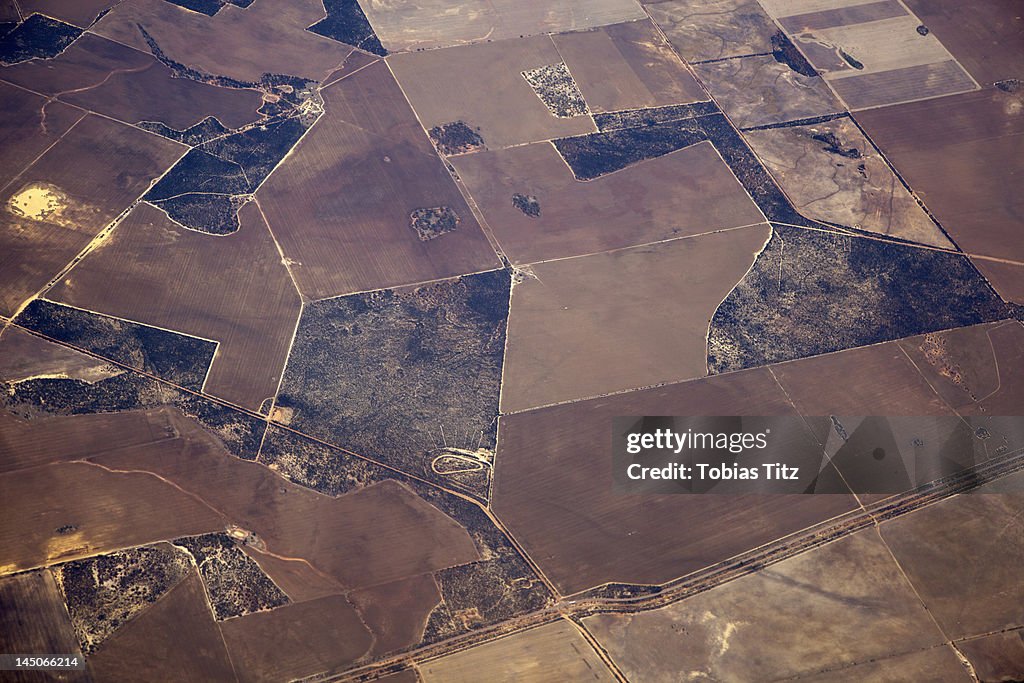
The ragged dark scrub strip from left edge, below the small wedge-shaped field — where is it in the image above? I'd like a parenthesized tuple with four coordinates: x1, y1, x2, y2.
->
(0, 372, 266, 460)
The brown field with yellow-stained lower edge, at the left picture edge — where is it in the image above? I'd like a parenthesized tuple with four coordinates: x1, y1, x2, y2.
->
(0, 458, 224, 573)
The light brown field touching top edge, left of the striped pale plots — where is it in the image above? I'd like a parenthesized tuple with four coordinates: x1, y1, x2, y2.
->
(644, 0, 778, 61)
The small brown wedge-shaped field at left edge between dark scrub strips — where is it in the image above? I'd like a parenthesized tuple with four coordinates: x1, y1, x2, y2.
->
(0, 327, 123, 383)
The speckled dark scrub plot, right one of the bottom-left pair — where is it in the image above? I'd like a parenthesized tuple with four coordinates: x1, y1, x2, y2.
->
(173, 533, 291, 622)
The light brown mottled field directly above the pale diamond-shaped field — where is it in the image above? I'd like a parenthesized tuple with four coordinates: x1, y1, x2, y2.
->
(693, 54, 843, 128)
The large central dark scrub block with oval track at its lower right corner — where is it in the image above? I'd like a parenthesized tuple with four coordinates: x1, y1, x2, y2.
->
(278, 270, 511, 496)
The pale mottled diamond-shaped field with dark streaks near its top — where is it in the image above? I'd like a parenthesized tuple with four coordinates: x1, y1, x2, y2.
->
(743, 119, 952, 249)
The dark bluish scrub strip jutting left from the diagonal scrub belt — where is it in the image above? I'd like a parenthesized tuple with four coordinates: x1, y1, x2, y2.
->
(554, 119, 708, 180)
